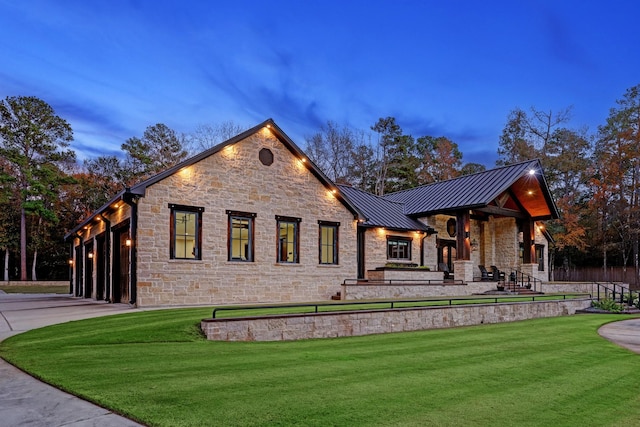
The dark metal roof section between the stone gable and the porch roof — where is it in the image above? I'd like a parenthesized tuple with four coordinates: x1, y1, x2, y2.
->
(338, 185, 430, 231)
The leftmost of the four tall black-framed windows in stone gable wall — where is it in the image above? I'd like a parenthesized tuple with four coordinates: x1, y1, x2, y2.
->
(169, 203, 204, 259)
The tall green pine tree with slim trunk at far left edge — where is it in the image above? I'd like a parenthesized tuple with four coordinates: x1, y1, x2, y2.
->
(0, 96, 75, 280)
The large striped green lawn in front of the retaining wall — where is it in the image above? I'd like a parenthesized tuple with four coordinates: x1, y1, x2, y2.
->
(0, 308, 640, 426)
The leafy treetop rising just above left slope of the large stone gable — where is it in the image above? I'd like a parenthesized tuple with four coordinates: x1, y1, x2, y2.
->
(121, 123, 187, 185)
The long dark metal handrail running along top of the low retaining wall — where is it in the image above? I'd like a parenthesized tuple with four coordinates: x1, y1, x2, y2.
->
(211, 292, 593, 319)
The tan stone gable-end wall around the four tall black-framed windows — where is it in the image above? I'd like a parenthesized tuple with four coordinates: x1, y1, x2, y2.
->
(138, 128, 357, 306)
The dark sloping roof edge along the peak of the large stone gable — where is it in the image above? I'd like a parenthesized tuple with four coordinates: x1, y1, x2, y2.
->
(64, 119, 364, 240)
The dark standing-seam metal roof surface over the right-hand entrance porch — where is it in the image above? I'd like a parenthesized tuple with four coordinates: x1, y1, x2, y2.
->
(384, 160, 558, 218)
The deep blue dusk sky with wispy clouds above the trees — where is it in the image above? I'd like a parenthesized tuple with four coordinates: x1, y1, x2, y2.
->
(0, 0, 640, 166)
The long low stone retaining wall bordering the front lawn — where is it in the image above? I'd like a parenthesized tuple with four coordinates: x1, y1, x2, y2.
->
(200, 298, 591, 341)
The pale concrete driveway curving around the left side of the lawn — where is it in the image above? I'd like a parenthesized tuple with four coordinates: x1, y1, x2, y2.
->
(0, 293, 140, 427)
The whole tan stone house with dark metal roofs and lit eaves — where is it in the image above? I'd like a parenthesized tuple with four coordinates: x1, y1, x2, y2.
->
(66, 119, 557, 306)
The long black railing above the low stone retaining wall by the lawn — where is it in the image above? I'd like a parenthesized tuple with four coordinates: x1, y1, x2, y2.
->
(211, 292, 592, 319)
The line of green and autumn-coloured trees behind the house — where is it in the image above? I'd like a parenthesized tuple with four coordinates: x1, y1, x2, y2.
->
(0, 85, 640, 280)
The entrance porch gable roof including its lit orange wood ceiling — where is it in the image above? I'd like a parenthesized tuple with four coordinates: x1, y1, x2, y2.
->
(384, 160, 559, 220)
